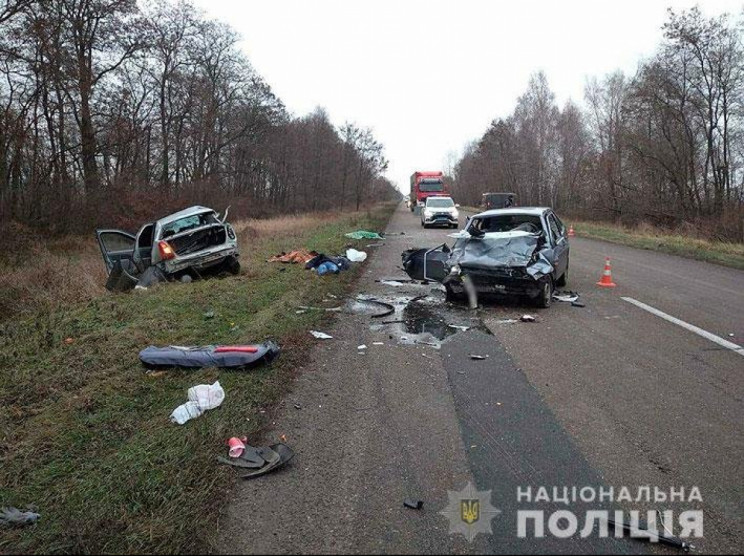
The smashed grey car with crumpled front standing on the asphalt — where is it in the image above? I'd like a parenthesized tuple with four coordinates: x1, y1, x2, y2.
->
(403, 207, 569, 307)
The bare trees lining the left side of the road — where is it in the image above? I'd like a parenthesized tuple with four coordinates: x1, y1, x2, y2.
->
(0, 0, 398, 231)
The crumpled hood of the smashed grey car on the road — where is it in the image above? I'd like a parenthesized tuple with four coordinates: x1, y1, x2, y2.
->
(447, 231, 554, 279)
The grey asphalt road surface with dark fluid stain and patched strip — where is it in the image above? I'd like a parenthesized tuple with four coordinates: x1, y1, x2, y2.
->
(215, 202, 744, 554)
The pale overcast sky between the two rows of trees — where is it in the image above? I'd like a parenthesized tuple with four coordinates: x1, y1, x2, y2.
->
(194, 0, 744, 192)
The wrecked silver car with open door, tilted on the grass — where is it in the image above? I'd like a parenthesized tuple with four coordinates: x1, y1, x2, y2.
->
(96, 206, 240, 291)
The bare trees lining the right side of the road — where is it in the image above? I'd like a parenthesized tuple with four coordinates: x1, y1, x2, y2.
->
(453, 8, 744, 241)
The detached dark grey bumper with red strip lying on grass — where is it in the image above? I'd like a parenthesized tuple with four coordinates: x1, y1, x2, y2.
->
(139, 342, 281, 369)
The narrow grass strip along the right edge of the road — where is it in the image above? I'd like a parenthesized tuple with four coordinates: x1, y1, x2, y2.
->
(566, 220, 744, 270)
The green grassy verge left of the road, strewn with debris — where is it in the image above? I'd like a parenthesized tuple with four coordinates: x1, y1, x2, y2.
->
(0, 206, 393, 553)
